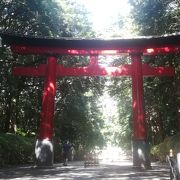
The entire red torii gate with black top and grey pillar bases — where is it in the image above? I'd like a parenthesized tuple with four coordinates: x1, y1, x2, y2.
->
(1, 34, 180, 168)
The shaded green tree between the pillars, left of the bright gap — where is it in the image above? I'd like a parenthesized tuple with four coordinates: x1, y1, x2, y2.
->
(55, 77, 104, 150)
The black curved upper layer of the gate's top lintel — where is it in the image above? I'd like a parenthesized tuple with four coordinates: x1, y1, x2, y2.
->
(0, 33, 180, 49)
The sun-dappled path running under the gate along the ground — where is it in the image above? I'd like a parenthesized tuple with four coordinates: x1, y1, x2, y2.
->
(0, 161, 169, 180)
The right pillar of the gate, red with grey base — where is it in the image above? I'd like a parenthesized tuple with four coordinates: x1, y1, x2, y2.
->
(131, 54, 151, 169)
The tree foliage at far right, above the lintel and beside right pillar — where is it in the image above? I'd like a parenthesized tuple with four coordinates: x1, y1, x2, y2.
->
(129, 0, 180, 144)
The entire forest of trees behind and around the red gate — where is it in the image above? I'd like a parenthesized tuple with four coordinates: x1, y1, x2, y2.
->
(0, 0, 180, 166)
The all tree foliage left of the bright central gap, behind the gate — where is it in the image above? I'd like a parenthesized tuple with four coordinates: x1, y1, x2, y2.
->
(0, 0, 103, 156)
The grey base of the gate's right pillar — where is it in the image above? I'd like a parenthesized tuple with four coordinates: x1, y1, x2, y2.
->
(133, 140, 151, 169)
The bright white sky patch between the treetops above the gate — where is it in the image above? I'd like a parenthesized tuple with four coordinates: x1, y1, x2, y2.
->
(79, 0, 130, 34)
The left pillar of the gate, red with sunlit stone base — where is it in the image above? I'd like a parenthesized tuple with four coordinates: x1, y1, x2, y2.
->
(35, 57, 57, 167)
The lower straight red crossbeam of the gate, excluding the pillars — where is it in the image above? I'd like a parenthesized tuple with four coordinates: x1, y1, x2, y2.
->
(12, 64, 175, 77)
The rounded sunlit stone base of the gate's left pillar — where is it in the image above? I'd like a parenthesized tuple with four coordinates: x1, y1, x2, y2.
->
(35, 139, 54, 167)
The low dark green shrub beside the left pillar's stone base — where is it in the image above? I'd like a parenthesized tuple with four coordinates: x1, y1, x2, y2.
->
(0, 133, 35, 166)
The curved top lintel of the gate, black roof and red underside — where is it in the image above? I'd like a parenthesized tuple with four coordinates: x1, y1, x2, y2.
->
(0, 33, 180, 55)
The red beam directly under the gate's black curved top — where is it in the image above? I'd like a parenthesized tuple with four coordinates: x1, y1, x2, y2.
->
(11, 45, 179, 55)
